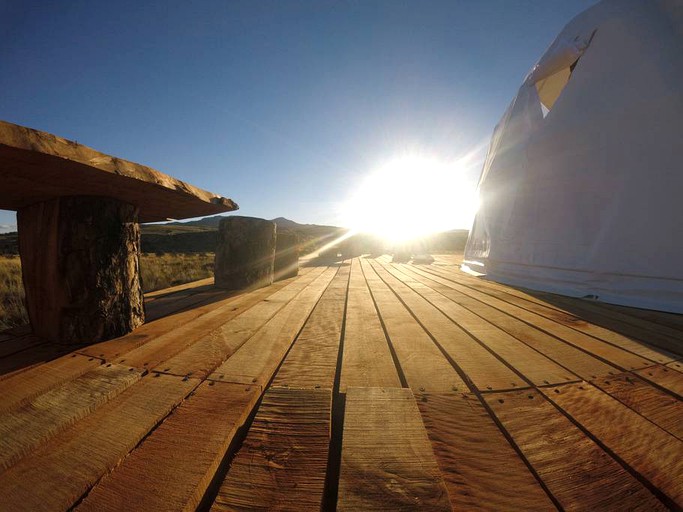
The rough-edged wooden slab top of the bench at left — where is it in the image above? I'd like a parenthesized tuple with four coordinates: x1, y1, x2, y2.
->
(0, 121, 238, 222)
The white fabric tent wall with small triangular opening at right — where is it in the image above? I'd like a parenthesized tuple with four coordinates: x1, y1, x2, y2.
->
(465, 0, 683, 313)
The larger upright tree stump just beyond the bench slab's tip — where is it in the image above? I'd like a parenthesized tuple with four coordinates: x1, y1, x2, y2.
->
(214, 216, 276, 290)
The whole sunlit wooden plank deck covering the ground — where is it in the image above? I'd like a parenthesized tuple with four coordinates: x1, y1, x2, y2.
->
(0, 256, 683, 511)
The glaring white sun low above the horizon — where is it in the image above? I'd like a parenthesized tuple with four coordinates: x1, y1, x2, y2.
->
(342, 156, 477, 243)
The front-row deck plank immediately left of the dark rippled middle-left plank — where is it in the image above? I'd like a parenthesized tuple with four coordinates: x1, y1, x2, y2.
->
(77, 382, 260, 511)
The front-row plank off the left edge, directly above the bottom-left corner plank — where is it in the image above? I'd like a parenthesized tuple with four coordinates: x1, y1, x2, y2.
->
(0, 365, 141, 470)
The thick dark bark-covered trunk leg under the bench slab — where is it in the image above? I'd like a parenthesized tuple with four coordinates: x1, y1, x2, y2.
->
(17, 196, 145, 343)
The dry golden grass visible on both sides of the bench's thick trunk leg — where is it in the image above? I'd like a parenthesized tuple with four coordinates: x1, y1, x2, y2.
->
(0, 253, 213, 331)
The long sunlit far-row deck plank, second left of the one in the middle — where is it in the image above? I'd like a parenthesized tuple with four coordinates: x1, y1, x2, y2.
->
(209, 267, 337, 387)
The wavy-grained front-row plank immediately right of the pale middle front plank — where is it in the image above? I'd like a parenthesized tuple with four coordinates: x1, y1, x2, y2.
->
(415, 393, 554, 510)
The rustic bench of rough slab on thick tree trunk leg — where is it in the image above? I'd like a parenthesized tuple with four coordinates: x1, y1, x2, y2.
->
(0, 121, 238, 343)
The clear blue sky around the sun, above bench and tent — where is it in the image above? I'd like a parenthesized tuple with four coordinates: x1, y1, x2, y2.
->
(0, 0, 595, 230)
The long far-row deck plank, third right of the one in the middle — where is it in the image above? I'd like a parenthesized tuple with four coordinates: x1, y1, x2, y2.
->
(374, 262, 578, 385)
